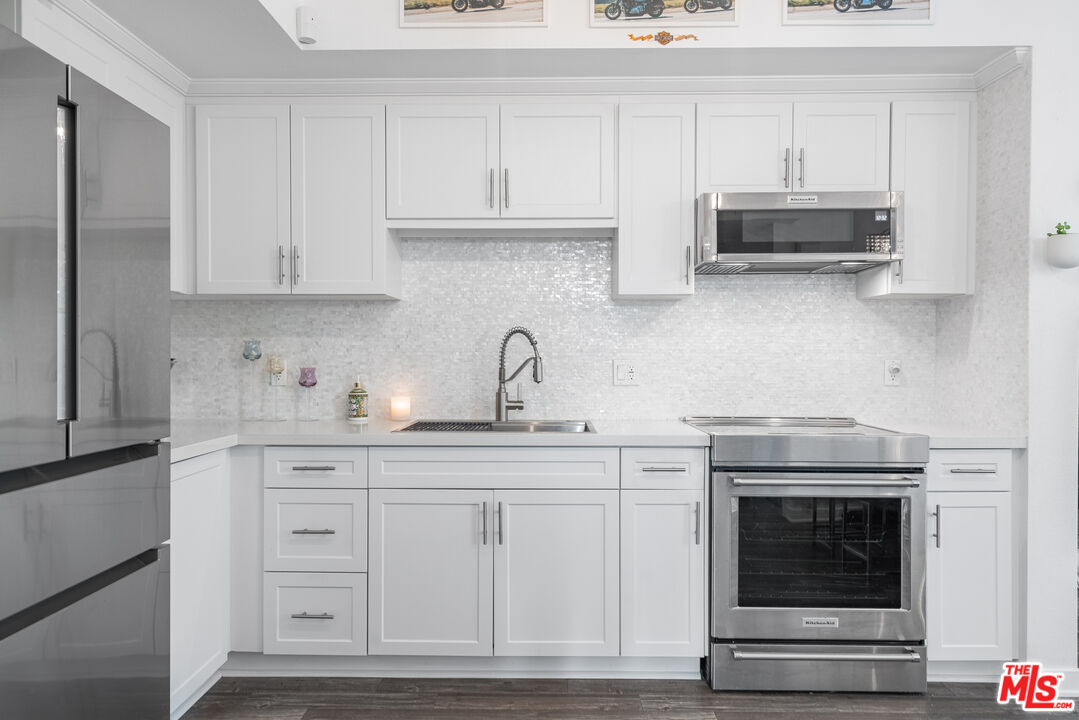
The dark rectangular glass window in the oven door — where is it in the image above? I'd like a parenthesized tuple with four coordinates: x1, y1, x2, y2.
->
(736, 497, 905, 609)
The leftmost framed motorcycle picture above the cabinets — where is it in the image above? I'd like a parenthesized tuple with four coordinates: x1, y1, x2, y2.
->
(398, 0, 547, 28)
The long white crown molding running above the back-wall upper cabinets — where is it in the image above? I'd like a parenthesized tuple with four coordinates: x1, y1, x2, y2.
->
(187, 74, 976, 98)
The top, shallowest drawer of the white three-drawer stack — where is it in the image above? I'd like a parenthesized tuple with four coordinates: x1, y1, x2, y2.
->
(262, 448, 367, 488)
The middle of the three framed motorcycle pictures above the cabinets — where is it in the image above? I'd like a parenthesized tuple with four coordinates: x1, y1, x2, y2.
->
(585, 0, 749, 27)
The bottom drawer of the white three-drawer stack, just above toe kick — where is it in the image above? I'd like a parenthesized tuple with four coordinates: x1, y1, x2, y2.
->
(262, 572, 367, 655)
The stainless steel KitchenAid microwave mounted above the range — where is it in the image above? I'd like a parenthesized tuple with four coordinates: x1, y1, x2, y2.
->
(695, 192, 903, 275)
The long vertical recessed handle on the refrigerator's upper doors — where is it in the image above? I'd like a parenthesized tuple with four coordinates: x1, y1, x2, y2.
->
(56, 101, 79, 422)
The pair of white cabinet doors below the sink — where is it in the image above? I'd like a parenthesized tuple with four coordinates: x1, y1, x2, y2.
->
(369, 489, 618, 655)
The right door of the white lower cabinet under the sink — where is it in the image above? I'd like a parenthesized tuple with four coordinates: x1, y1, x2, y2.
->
(494, 490, 618, 655)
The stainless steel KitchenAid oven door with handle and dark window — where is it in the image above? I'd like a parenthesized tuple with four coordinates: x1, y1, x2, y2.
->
(712, 472, 926, 642)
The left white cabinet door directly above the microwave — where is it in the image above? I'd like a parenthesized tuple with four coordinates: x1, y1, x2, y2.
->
(697, 103, 794, 194)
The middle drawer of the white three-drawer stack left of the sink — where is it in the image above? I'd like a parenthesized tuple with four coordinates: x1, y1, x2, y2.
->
(262, 489, 367, 572)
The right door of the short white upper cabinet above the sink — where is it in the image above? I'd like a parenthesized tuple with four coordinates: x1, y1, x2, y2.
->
(501, 104, 615, 218)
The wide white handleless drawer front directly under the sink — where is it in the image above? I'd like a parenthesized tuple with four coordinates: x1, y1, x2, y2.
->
(371, 447, 618, 490)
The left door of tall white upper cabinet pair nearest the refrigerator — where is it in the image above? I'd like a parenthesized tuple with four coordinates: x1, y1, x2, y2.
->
(195, 105, 291, 295)
